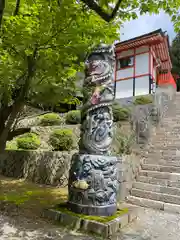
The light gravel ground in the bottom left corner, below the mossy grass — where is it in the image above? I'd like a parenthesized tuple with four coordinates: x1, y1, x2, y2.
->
(0, 215, 94, 240)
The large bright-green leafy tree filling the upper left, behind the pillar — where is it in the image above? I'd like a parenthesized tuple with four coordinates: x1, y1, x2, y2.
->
(0, 0, 119, 150)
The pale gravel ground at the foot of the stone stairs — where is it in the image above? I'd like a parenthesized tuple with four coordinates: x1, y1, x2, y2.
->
(112, 208, 180, 240)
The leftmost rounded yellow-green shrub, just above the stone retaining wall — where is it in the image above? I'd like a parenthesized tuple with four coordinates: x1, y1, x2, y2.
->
(16, 133, 41, 150)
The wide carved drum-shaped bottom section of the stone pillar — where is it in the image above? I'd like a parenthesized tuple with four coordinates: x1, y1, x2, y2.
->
(68, 154, 119, 216)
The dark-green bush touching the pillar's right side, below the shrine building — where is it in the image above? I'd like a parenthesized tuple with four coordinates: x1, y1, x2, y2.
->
(112, 103, 130, 122)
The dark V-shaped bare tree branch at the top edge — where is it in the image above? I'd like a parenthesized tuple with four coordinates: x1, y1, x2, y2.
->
(81, 0, 123, 22)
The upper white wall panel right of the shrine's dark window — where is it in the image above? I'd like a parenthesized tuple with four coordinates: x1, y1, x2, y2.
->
(135, 53, 149, 76)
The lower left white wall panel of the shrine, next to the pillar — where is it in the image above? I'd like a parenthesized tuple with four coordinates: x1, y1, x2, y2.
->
(116, 78, 133, 99)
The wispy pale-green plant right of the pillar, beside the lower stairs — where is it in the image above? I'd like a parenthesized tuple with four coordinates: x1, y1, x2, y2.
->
(116, 133, 135, 155)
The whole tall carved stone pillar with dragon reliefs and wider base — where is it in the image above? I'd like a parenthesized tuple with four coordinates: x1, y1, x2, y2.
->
(68, 44, 118, 216)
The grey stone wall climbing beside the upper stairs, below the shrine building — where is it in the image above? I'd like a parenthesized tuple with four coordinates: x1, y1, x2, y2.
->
(131, 85, 176, 144)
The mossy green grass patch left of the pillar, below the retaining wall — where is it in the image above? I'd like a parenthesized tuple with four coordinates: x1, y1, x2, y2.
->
(0, 176, 68, 215)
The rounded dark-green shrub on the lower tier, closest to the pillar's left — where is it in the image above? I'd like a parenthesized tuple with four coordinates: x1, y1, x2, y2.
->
(49, 129, 74, 151)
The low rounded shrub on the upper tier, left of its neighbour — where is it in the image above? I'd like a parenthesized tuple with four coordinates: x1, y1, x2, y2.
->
(40, 113, 62, 126)
